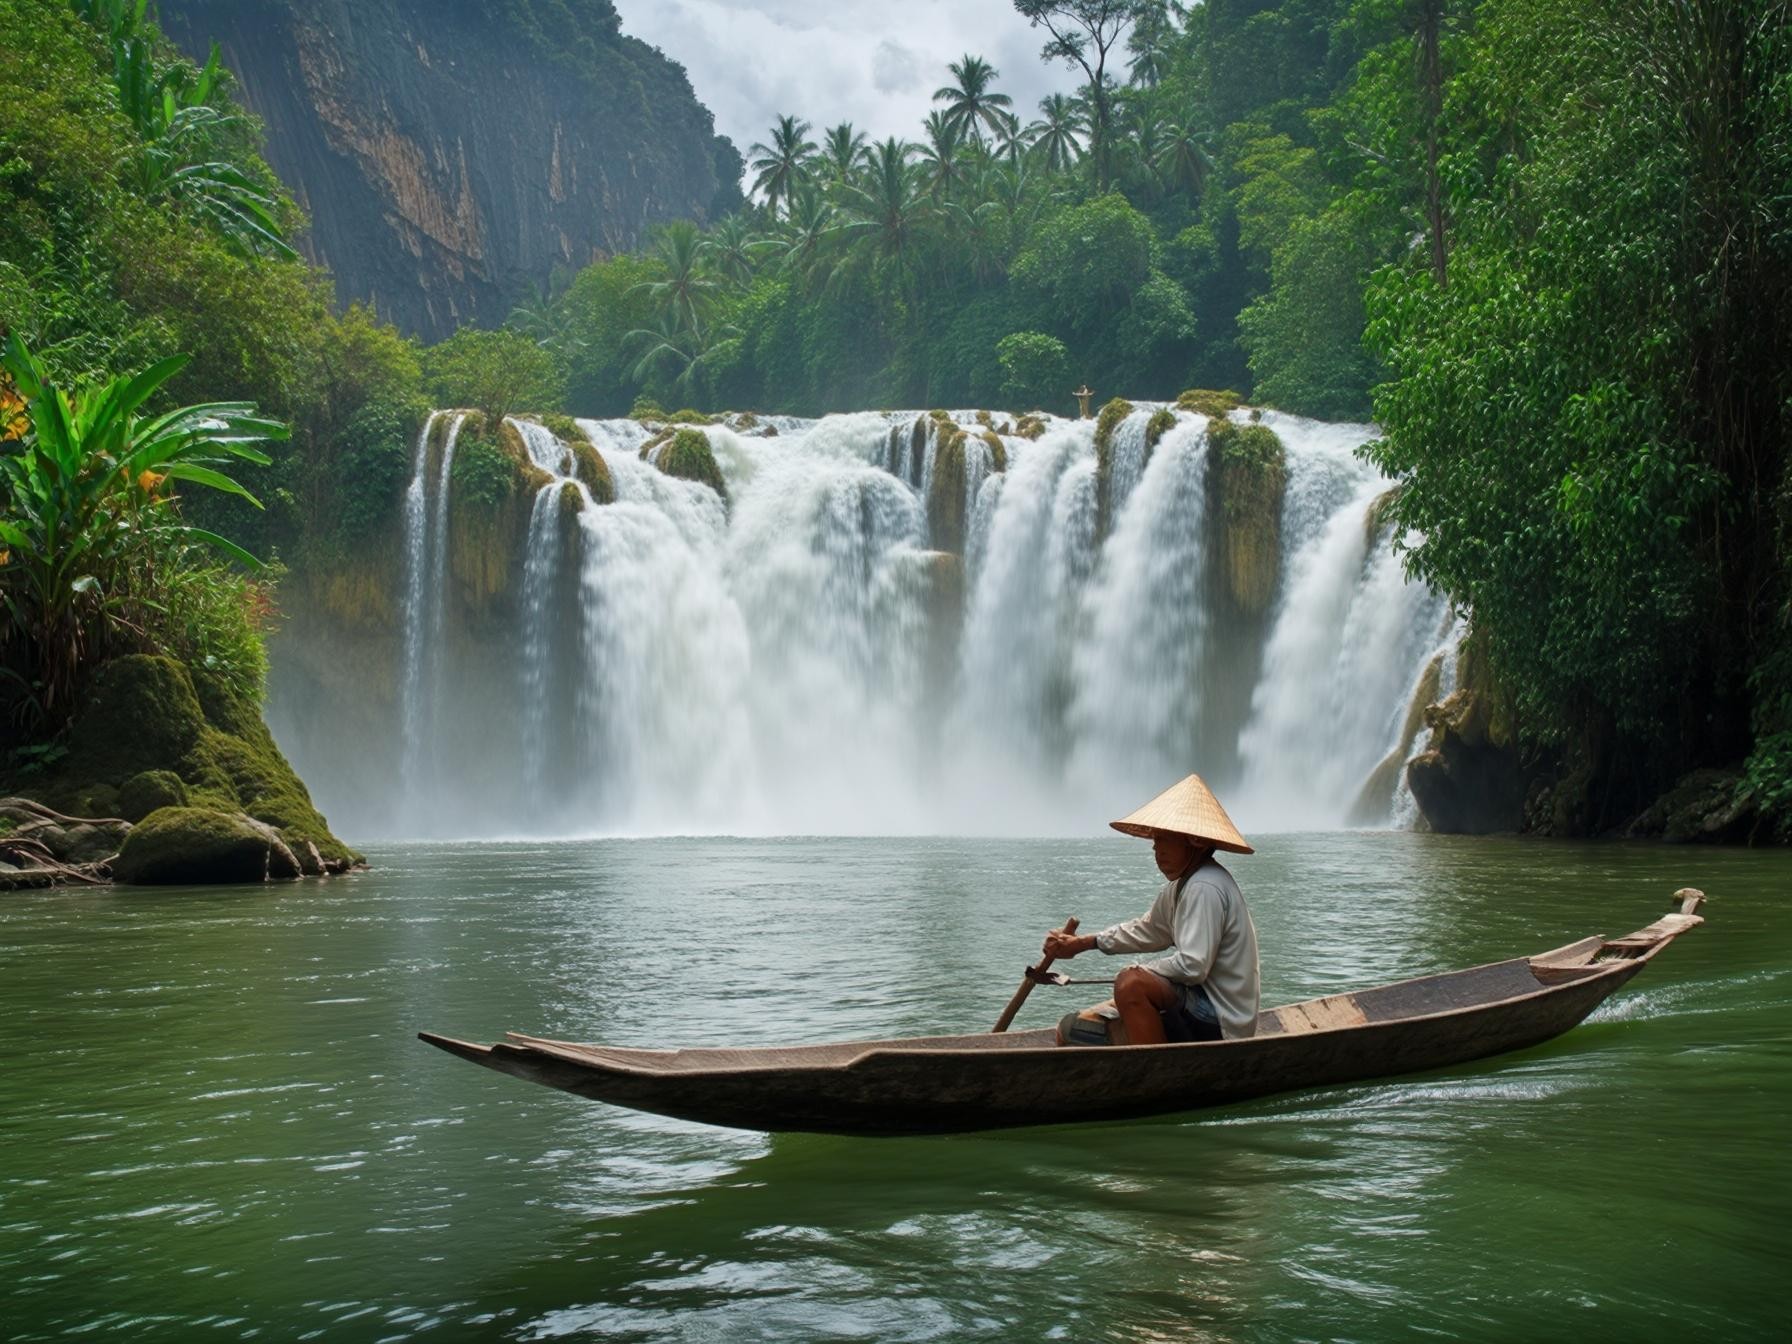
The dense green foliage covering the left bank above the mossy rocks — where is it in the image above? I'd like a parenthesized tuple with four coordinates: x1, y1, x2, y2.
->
(0, 0, 423, 788)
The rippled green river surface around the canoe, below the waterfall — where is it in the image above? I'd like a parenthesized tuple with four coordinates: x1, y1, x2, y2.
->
(0, 833, 1792, 1340)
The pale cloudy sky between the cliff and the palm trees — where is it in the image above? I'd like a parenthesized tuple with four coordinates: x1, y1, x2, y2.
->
(615, 0, 1081, 156)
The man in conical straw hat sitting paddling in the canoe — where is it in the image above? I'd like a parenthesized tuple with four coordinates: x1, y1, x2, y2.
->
(1045, 774, 1258, 1045)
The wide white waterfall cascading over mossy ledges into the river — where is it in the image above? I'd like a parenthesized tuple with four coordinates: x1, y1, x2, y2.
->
(329, 410, 1450, 835)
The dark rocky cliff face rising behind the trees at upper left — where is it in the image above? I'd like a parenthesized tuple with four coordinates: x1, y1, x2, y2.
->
(159, 0, 740, 339)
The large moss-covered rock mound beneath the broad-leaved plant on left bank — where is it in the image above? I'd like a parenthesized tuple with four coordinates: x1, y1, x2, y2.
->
(16, 654, 360, 871)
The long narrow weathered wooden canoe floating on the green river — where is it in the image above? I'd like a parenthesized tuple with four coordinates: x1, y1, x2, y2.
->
(419, 889, 1704, 1134)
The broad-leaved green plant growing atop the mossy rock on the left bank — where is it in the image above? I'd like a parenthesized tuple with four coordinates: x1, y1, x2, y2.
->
(0, 332, 289, 724)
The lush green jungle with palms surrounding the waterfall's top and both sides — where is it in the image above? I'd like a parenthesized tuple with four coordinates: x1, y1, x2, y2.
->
(0, 0, 1792, 842)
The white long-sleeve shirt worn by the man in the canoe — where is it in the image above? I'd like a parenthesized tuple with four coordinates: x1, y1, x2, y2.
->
(1095, 858, 1258, 1039)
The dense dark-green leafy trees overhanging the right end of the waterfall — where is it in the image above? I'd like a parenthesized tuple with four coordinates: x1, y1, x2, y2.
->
(1369, 0, 1792, 826)
